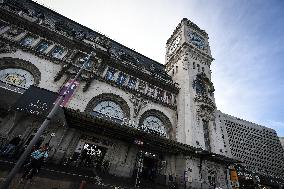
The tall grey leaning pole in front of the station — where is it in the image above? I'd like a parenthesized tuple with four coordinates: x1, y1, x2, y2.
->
(0, 46, 95, 189)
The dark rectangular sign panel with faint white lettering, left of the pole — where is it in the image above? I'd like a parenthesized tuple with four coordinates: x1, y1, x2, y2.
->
(12, 86, 58, 116)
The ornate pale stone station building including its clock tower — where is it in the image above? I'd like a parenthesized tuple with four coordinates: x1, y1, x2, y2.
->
(0, 0, 282, 189)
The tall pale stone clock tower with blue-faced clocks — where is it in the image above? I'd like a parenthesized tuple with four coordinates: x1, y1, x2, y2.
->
(166, 18, 225, 154)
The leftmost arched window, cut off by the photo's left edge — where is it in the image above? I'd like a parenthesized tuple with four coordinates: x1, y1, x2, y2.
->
(0, 68, 34, 89)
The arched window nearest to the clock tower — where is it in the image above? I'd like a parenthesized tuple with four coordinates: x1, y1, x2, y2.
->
(142, 116, 168, 138)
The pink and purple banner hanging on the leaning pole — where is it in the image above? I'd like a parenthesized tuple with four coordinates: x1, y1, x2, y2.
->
(59, 79, 79, 107)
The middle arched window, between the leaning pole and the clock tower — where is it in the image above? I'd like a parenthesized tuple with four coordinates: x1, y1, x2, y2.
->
(93, 100, 124, 120)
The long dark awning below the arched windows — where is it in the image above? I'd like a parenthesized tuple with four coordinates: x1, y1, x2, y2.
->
(64, 108, 237, 163)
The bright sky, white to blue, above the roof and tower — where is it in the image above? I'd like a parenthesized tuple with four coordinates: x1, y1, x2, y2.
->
(33, 0, 284, 136)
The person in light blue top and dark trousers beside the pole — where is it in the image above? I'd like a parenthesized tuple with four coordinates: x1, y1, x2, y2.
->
(20, 143, 49, 183)
